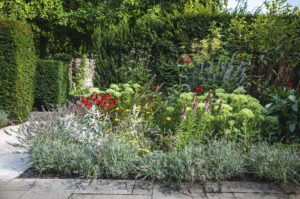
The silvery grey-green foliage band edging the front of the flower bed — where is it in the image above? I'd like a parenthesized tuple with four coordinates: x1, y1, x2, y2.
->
(20, 107, 300, 182)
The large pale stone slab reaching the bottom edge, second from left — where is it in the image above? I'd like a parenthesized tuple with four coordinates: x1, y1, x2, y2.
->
(20, 179, 81, 199)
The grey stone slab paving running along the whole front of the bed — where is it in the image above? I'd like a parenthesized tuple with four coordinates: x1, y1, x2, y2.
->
(0, 179, 300, 199)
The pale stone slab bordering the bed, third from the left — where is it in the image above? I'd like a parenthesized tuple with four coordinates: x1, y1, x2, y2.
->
(74, 180, 134, 195)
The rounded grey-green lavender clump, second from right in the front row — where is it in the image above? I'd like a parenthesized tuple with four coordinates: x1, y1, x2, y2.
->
(203, 141, 246, 180)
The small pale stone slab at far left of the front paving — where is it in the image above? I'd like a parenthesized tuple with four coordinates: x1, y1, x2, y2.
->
(0, 179, 36, 191)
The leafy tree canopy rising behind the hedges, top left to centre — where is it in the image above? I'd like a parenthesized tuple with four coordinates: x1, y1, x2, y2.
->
(0, 0, 227, 58)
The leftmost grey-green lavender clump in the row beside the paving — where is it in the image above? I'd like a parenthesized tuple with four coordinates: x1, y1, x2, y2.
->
(29, 137, 101, 177)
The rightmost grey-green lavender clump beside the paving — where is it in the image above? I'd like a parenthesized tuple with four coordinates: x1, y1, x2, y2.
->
(249, 143, 300, 182)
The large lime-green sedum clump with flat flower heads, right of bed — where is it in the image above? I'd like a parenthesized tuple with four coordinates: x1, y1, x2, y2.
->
(178, 89, 278, 148)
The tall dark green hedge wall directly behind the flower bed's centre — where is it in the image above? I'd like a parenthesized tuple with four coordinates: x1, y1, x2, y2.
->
(93, 12, 233, 86)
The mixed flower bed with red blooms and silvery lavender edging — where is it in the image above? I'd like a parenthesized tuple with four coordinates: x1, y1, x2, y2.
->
(17, 78, 300, 182)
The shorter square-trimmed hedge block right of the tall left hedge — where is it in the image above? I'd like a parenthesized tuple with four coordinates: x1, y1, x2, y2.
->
(35, 60, 68, 109)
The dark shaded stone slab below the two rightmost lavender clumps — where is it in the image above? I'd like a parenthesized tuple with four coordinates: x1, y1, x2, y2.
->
(222, 181, 283, 193)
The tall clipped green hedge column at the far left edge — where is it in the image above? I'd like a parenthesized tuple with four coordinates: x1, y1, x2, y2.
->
(0, 19, 36, 121)
